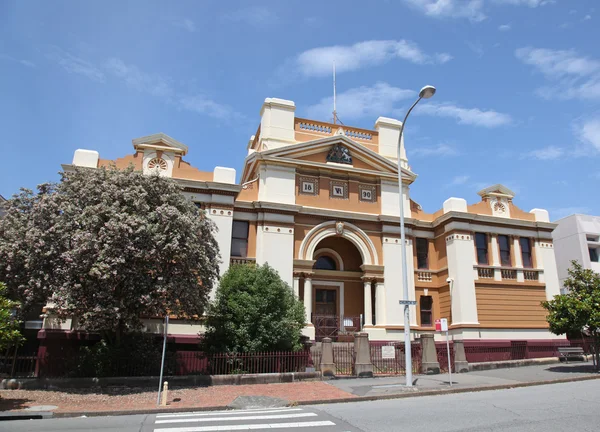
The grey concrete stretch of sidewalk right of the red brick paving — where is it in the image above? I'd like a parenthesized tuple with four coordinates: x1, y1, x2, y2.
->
(329, 363, 600, 397)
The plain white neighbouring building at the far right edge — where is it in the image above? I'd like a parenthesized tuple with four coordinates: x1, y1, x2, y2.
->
(552, 214, 600, 289)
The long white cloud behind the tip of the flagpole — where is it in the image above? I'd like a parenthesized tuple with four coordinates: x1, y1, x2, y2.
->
(288, 39, 452, 76)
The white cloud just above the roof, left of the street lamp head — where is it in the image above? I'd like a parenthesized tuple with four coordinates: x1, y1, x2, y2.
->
(307, 82, 416, 121)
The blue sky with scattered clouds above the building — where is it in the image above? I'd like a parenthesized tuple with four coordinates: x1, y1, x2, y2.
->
(0, 0, 600, 219)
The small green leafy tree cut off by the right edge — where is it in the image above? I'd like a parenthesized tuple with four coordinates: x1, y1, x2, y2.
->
(542, 261, 600, 370)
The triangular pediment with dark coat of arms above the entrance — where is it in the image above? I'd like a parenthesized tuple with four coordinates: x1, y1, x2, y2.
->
(249, 135, 416, 180)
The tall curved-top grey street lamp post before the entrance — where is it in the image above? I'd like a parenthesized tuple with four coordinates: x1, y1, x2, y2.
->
(398, 86, 435, 387)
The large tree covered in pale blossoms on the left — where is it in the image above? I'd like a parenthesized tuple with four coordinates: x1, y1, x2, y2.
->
(0, 168, 219, 344)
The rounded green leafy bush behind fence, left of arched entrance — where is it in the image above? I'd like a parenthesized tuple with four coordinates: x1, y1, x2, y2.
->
(201, 265, 305, 353)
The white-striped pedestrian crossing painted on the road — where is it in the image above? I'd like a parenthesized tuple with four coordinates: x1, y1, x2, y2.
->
(152, 407, 356, 432)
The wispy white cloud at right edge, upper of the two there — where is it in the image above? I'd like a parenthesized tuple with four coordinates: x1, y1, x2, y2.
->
(515, 47, 600, 99)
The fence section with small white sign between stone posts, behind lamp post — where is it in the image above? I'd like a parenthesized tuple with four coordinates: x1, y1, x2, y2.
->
(369, 341, 421, 375)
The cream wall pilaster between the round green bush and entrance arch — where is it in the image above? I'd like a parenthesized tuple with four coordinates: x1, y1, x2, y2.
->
(256, 225, 294, 287)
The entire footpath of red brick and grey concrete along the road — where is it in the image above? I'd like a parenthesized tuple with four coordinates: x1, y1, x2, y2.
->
(0, 362, 600, 418)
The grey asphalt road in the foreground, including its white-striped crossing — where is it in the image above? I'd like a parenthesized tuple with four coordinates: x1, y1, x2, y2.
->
(0, 380, 600, 432)
